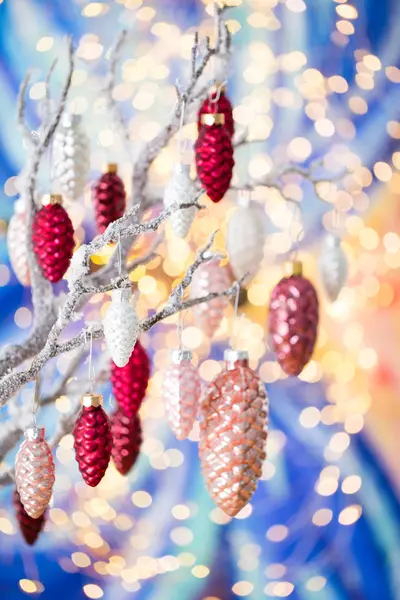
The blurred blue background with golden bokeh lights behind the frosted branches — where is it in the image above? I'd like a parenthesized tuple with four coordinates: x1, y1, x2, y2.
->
(0, 0, 400, 600)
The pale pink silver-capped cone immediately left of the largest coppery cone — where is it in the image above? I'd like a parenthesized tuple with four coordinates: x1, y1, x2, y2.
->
(163, 350, 201, 440)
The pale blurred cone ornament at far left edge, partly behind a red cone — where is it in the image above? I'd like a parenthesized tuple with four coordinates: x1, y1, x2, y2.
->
(7, 198, 31, 286)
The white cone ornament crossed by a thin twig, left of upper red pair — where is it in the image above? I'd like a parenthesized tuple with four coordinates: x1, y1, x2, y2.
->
(164, 165, 196, 238)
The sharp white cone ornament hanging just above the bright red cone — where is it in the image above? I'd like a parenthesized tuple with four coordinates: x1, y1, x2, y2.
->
(103, 288, 139, 367)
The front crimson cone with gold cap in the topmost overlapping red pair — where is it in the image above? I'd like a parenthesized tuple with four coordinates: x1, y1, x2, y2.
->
(195, 113, 235, 202)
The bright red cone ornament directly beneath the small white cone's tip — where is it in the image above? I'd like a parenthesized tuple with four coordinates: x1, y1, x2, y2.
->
(111, 340, 150, 417)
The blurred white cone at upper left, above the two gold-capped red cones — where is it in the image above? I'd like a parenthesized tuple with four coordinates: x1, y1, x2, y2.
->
(53, 113, 90, 201)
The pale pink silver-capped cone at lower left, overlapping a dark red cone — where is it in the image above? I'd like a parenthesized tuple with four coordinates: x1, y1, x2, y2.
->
(15, 427, 55, 519)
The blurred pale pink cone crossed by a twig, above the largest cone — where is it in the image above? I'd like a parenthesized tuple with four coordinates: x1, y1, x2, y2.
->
(190, 259, 231, 337)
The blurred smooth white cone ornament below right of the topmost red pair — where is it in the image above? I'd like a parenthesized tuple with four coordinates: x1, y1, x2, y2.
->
(226, 196, 265, 279)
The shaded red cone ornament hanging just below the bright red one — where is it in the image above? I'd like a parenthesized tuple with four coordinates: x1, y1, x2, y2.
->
(111, 409, 142, 475)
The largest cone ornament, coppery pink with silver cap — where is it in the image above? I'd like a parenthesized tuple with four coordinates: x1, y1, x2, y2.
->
(199, 350, 268, 517)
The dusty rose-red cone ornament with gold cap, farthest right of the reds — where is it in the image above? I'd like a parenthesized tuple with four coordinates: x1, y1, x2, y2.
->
(268, 262, 318, 375)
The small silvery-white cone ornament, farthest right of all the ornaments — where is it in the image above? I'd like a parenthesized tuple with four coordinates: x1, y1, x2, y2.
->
(319, 233, 348, 302)
